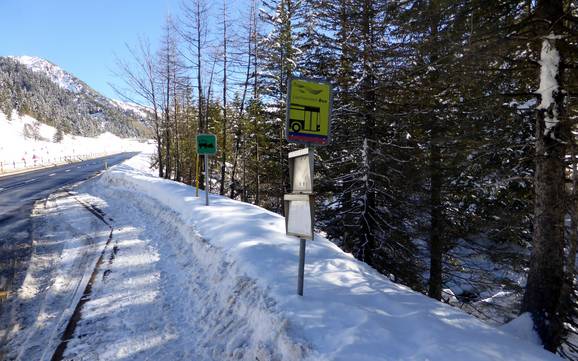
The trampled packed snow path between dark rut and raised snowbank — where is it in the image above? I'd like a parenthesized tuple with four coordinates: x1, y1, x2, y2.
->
(64, 181, 304, 361)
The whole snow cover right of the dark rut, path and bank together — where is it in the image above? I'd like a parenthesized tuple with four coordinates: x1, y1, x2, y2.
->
(58, 154, 558, 361)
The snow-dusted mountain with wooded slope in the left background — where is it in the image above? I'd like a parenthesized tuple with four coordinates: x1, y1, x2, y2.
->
(0, 56, 151, 137)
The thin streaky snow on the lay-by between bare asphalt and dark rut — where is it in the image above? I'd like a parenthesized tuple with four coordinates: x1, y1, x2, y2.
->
(0, 192, 110, 361)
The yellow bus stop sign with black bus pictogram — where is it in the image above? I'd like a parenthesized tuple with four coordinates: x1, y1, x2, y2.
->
(287, 78, 332, 145)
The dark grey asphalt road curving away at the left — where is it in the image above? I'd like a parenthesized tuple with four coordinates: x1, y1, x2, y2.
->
(0, 153, 137, 291)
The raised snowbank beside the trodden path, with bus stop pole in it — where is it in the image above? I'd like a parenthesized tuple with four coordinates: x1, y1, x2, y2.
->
(99, 155, 558, 361)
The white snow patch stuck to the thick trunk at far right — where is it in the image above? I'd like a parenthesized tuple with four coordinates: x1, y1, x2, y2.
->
(537, 34, 560, 136)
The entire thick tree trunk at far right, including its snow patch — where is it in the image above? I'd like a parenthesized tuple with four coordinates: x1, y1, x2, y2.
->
(521, 0, 570, 351)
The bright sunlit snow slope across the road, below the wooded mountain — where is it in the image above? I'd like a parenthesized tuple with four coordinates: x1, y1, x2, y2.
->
(0, 111, 147, 173)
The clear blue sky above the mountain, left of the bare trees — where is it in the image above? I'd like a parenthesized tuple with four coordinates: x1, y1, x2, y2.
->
(0, 0, 181, 98)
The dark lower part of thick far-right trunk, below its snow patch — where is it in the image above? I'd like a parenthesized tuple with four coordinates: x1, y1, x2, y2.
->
(522, 105, 565, 351)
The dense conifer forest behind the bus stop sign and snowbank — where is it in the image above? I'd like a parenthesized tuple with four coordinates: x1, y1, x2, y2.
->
(116, 0, 578, 354)
